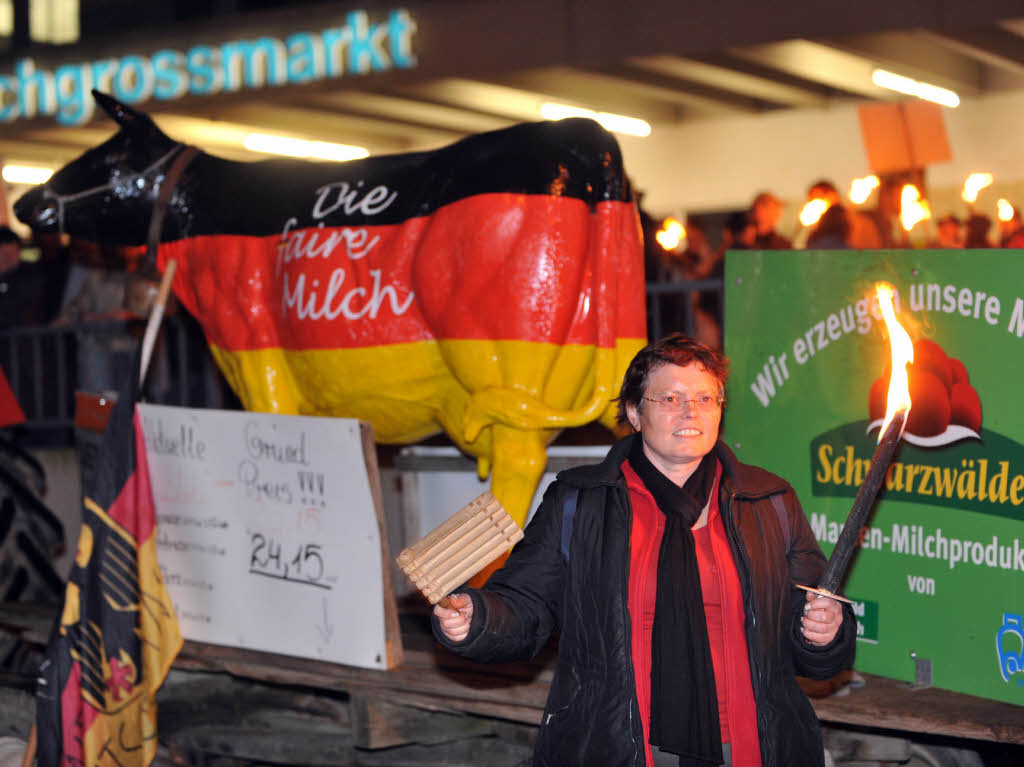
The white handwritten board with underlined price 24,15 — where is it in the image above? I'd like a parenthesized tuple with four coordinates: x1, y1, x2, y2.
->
(139, 404, 400, 669)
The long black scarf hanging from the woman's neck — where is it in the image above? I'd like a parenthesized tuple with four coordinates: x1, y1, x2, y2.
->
(629, 435, 722, 767)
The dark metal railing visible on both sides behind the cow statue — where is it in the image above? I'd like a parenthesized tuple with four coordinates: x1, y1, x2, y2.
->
(0, 279, 723, 444)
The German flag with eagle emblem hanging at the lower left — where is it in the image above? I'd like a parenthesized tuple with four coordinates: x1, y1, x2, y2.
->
(36, 350, 182, 767)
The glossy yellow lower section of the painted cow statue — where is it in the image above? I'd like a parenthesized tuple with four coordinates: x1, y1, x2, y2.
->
(211, 338, 645, 526)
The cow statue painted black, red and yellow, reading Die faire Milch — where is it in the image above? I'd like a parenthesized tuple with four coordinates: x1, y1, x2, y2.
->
(15, 91, 646, 525)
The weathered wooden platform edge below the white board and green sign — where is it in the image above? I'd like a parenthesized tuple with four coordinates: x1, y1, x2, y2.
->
(0, 603, 1024, 744)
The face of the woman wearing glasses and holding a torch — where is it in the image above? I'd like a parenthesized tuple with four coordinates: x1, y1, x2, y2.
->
(626, 363, 722, 484)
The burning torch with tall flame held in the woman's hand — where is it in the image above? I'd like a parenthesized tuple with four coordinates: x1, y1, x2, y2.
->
(800, 283, 913, 602)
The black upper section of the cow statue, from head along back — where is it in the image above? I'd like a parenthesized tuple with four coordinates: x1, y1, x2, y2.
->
(14, 91, 632, 245)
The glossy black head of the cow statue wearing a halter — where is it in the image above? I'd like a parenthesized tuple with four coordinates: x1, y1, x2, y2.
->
(14, 90, 180, 245)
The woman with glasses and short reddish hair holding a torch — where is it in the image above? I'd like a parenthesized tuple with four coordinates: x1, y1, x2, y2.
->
(434, 334, 855, 767)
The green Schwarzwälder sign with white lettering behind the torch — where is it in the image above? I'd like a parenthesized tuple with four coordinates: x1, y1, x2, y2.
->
(724, 250, 1024, 706)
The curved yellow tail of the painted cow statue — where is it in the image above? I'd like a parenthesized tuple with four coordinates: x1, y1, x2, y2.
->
(462, 348, 618, 442)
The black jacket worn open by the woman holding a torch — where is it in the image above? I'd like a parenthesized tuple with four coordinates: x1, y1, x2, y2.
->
(434, 435, 856, 767)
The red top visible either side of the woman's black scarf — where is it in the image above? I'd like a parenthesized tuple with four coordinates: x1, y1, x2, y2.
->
(622, 461, 761, 767)
